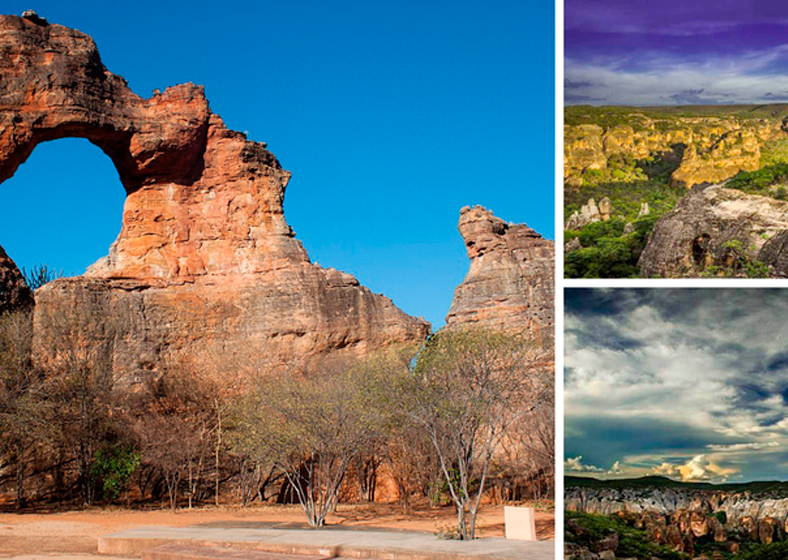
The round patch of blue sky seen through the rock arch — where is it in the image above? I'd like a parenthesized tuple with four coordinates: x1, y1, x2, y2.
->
(0, 138, 126, 276)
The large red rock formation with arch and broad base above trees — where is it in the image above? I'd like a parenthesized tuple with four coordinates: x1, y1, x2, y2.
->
(0, 16, 429, 371)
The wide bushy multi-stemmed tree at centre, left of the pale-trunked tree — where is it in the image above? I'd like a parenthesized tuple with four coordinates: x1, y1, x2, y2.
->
(231, 363, 385, 527)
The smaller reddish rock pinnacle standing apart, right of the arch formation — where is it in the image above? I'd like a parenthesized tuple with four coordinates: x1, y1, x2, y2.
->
(446, 206, 555, 330)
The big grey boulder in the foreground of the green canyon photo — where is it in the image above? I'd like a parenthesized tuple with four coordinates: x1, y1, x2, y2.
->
(638, 185, 788, 278)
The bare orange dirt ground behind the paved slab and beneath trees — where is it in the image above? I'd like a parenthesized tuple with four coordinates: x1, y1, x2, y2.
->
(0, 504, 555, 560)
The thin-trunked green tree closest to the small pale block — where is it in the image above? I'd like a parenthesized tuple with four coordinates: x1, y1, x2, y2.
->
(400, 329, 553, 539)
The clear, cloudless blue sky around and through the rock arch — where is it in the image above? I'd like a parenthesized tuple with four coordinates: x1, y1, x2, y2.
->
(0, 0, 555, 327)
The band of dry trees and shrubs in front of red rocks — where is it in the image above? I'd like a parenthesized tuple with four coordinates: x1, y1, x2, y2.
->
(0, 312, 554, 538)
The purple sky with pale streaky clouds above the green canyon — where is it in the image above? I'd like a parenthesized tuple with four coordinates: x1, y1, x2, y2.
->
(564, 0, 788, 105)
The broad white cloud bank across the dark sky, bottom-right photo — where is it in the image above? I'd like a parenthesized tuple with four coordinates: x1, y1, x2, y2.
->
(565, 298, 788, 440)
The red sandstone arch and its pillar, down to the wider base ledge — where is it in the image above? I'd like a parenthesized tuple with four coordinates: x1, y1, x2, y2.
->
(0, 16, 296, 278)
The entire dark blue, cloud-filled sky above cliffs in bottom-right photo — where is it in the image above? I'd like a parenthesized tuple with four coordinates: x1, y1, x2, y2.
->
(564, 288, 788, 482)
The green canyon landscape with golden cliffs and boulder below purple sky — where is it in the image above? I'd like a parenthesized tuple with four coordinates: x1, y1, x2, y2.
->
(564, 105, 788, 278)
